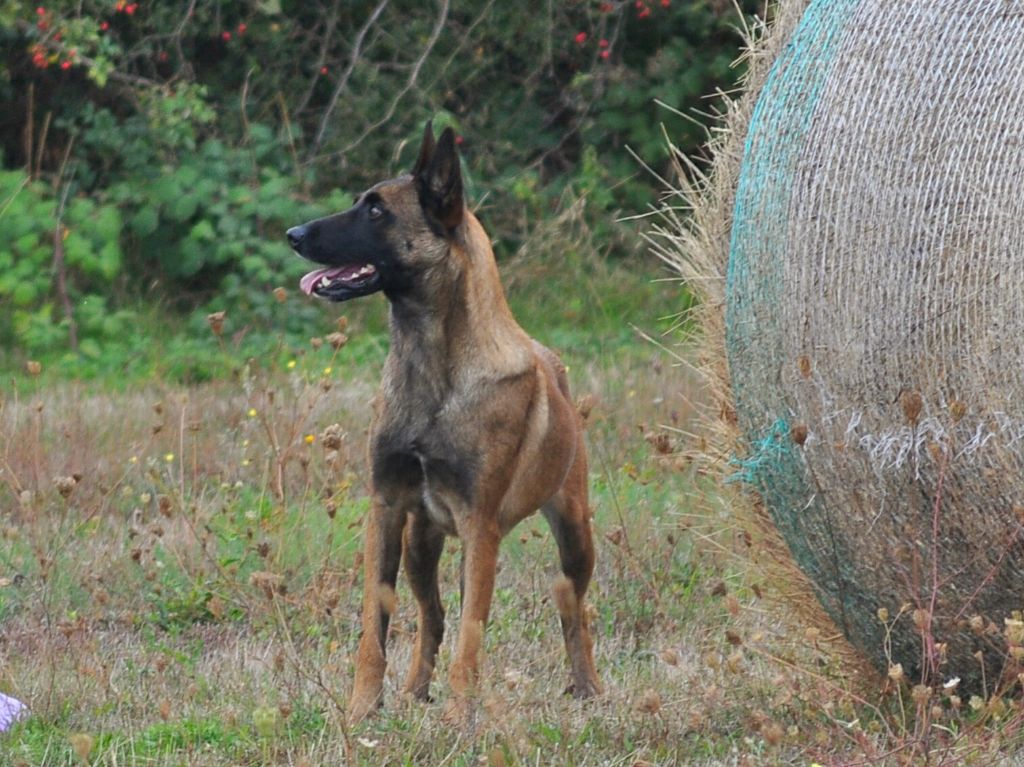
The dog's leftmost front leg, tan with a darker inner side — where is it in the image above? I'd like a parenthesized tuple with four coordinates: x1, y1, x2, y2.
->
(348, 497, 407, 723)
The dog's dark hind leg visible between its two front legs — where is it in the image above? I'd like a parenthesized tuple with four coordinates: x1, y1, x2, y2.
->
(406, 509, 444, 700)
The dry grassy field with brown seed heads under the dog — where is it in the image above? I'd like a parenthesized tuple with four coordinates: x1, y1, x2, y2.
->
(0, 243, 1022, 767)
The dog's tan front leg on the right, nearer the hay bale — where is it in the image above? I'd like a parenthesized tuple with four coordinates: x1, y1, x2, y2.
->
(444, 511, 501, 726)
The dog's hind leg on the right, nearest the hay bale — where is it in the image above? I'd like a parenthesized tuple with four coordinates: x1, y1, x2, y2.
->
(543, 445, 601, 697)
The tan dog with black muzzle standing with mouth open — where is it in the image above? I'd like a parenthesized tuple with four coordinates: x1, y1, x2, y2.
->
(288, 125, 600, 722)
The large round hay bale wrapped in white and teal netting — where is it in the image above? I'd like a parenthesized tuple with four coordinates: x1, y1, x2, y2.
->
(660, 0, 1024, 691)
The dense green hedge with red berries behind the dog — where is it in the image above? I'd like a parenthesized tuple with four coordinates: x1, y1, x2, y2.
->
(0, 0, 759, 380)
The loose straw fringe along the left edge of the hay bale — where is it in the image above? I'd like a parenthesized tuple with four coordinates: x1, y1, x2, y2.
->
(648, 0, 867, 651)
